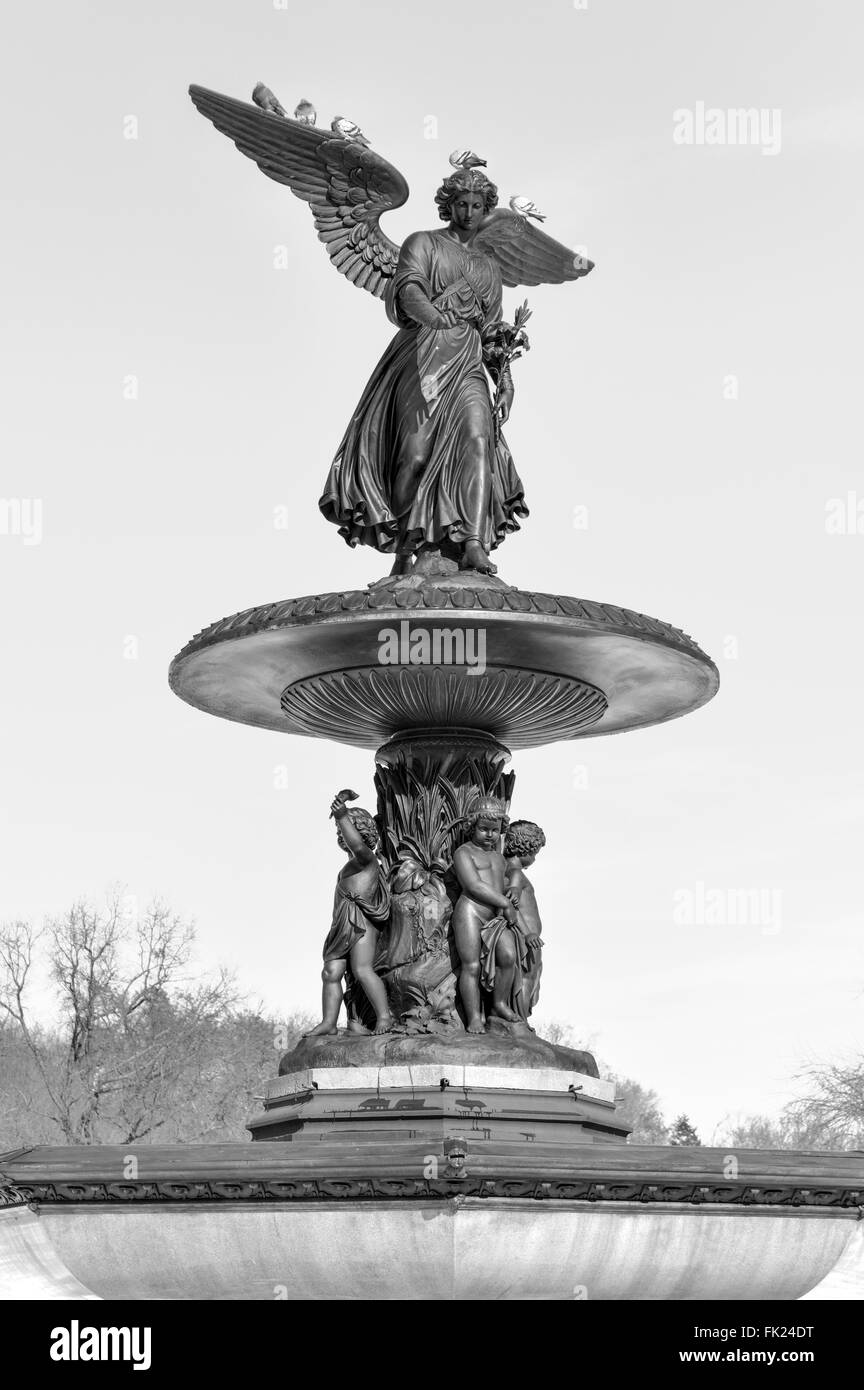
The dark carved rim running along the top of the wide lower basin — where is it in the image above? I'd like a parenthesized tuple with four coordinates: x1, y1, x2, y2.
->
(0, 1145, 864, 1212)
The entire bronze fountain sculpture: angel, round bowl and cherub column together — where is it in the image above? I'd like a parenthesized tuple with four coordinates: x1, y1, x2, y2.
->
(171, 73, 718, 1106)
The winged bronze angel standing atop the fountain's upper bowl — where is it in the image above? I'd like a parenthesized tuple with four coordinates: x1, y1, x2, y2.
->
(189, 86, 592, 574)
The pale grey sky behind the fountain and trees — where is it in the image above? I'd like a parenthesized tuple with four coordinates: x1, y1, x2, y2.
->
(0, 0, 864, 1140)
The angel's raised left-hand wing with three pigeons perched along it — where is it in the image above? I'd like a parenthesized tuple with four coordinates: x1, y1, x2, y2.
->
(189, 86, 408, 299)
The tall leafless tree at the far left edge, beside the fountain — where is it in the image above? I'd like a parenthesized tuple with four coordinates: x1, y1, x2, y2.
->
(0, 894, 238, 1144)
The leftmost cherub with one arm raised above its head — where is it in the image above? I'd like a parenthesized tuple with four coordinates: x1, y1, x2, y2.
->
(307, 792, 393, 1037)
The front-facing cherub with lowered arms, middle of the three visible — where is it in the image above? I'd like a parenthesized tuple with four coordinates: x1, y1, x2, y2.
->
(453, 796, 525, 1033)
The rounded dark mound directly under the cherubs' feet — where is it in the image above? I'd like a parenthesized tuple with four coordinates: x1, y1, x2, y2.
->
(279, 1026, 599, 1090)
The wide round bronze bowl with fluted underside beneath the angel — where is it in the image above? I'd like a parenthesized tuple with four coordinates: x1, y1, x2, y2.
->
(171, 584, 720, 749)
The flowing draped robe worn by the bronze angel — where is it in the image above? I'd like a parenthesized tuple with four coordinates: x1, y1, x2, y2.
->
(318, 231, 528, 553)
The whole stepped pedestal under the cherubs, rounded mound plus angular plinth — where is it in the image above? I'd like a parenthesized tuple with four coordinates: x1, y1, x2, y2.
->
(256, 1020, 629, 1163)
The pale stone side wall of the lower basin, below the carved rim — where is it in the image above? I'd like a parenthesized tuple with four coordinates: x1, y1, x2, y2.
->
(6, 1198, 864, 1301)
